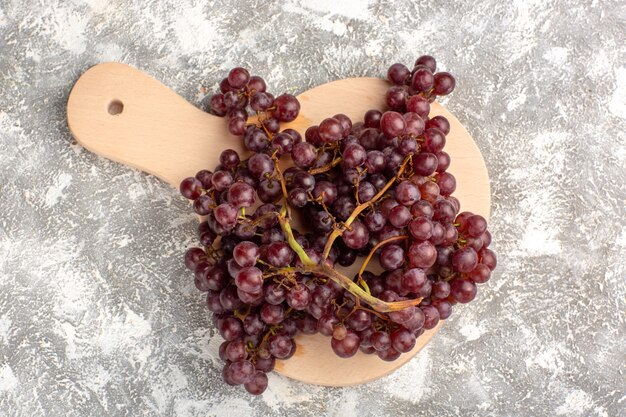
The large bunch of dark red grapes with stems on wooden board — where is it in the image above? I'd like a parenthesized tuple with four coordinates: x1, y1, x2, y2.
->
(180, 56, 496, 394)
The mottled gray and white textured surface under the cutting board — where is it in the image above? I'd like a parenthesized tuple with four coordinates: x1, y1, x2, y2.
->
(0, 0, 626, 417)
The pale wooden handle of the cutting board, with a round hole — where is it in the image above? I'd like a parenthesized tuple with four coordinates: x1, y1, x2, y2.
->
(67, 62, 234, 185)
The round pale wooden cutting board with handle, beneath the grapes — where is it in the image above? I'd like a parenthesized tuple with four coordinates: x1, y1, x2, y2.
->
(67, 62, 490, 386)
